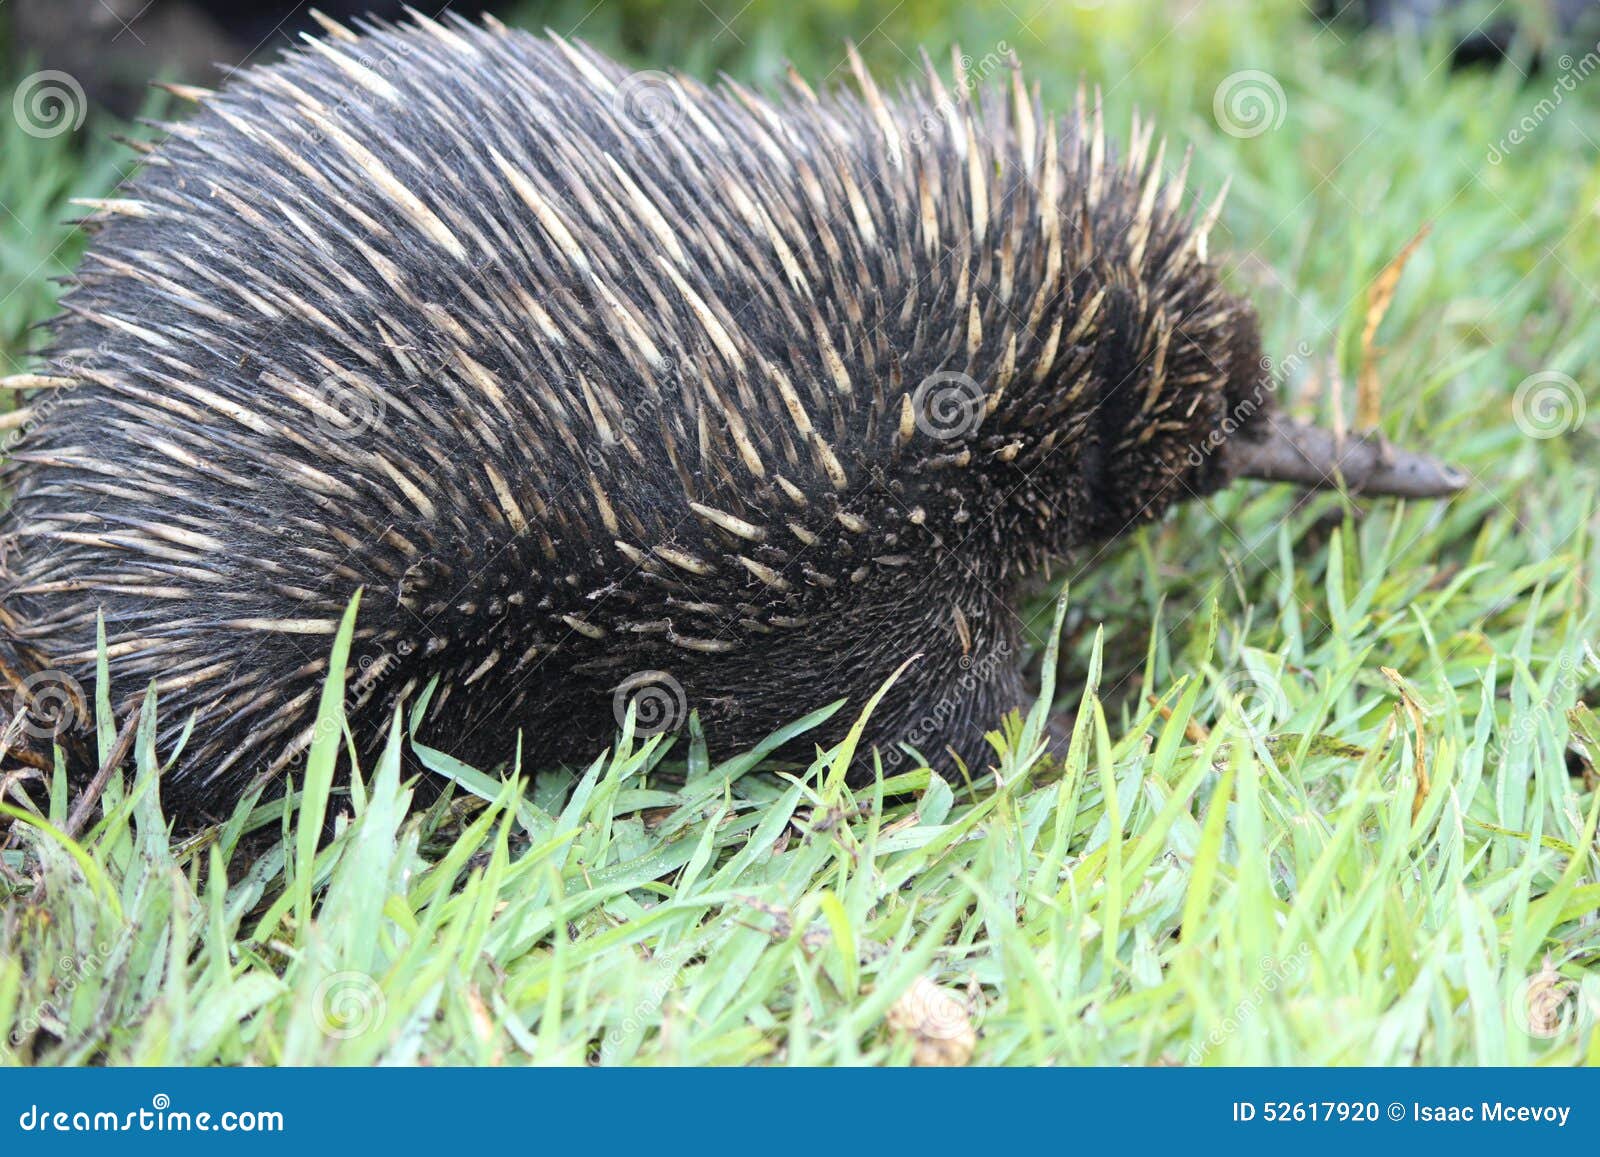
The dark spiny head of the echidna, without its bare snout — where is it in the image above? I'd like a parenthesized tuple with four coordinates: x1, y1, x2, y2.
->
(918, 202, 1275, 562)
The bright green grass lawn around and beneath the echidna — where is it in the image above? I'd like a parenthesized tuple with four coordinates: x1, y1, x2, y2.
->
(0, 0, 1600, 1064)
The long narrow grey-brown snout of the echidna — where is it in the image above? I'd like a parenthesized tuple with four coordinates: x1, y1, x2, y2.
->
(1221, 418, 1470, 498)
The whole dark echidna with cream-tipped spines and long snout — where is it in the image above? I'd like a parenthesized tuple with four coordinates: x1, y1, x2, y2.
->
(0, 16, 1458, 823)
